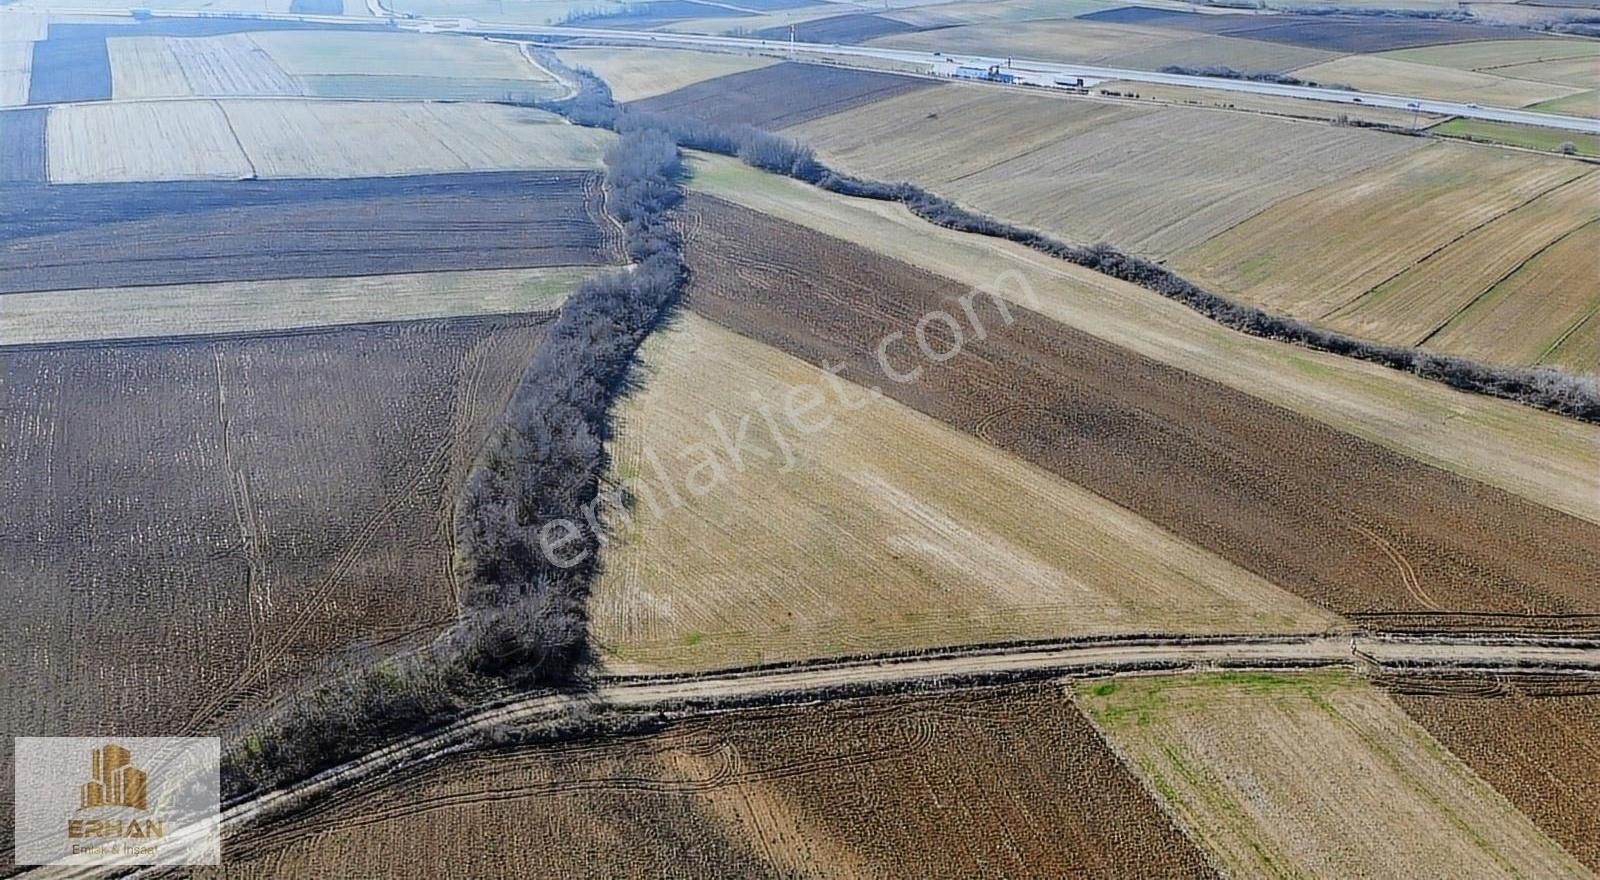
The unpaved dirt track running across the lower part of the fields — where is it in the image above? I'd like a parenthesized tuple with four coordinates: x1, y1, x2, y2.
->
(24, 634, 1600, 877)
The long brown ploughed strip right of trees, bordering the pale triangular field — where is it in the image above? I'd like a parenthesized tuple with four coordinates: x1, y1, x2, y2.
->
(686, 195, 1600, 630)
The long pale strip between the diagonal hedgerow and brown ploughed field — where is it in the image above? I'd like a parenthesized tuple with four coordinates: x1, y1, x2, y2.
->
(691, 157, 1600, 522)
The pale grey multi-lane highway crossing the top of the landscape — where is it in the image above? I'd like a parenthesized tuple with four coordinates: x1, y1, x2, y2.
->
(12, 0, 1600, 134)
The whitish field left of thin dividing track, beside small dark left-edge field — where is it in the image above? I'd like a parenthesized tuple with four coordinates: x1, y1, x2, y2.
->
(45, 101, 253, 184)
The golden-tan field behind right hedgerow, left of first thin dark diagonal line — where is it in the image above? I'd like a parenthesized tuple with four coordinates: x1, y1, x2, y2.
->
(1173, 144, 1589, 318)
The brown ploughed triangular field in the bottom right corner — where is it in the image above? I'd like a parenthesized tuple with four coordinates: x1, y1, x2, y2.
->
(1390, 678, 1600, 870)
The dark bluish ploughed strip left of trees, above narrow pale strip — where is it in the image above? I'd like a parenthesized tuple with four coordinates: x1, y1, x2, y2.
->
(0, 171, 616, 293)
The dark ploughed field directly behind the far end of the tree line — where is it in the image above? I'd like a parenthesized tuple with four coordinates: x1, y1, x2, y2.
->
(629, 61, 938, 128)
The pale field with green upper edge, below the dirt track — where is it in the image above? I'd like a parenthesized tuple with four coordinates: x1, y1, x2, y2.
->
(1077, 672, 1592, 878)
